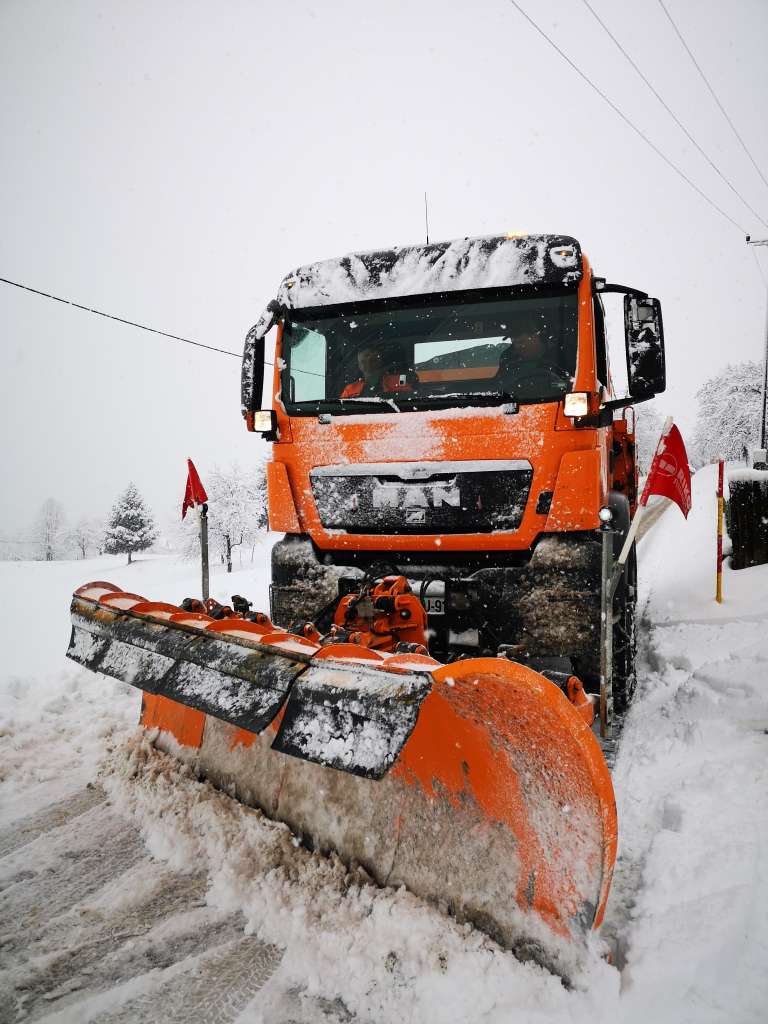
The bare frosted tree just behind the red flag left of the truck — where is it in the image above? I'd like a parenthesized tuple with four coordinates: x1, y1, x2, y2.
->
(182, 463, 266, 572)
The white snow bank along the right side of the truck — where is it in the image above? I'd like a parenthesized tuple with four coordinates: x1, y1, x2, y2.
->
(607, 467, 768, 1024)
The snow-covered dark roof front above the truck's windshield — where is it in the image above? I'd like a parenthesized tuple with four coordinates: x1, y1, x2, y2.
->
(278, 234, 582, 309)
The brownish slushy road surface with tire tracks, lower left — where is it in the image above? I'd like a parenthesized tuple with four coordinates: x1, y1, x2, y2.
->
(0, 787, 283, 1024)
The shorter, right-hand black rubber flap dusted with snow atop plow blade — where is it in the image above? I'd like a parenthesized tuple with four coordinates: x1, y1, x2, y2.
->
(272, 662, 432, 779)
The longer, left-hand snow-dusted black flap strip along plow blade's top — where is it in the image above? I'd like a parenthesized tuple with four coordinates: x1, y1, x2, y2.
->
(67, 596, 305, 732)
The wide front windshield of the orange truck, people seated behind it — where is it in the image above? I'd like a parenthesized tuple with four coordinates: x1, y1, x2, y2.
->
(282, 292, 578, 415)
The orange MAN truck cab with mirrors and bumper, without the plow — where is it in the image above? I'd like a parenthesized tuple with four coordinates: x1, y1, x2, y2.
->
(242, 234, 665, 700)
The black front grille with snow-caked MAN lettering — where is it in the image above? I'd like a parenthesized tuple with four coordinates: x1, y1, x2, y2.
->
(309, 459, 532, 536)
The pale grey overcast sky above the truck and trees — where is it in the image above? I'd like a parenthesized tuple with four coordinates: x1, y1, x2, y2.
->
(0, 0, 768, 539)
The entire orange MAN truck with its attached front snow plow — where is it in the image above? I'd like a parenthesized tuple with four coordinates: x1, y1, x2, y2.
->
(68, 234, 665, 968)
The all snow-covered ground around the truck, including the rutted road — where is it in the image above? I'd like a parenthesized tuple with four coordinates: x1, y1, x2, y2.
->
(0, 468, 768, 1024)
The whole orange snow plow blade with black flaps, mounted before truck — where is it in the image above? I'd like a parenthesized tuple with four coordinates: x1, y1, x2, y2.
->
(68, 584, 616, 969)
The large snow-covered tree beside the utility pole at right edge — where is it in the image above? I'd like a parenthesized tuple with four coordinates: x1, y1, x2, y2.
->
(692, 362, 763, 466)
